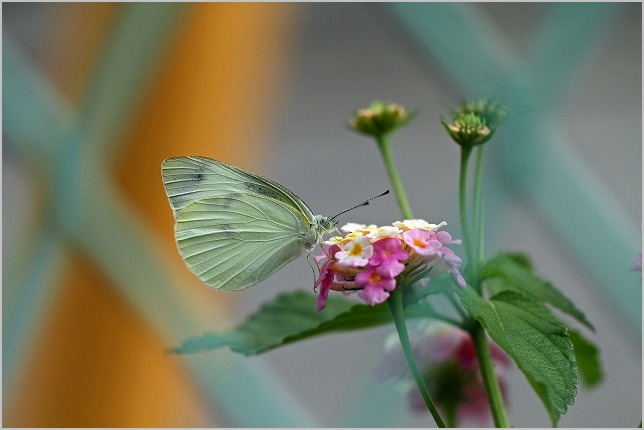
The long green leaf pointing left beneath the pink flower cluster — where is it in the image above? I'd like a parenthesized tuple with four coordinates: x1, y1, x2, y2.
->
(171, 291, 440, 355)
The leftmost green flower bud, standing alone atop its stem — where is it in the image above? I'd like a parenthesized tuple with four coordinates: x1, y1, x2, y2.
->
(351, 101, 414, 137)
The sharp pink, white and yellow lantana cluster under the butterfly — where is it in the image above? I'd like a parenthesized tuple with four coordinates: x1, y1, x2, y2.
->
(314, 219, 465, 311)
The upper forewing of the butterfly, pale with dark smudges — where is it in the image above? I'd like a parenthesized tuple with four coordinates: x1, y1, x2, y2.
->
(161, 156, 313, 221)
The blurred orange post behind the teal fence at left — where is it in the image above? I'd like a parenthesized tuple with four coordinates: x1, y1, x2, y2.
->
(3, 3, 298, 427)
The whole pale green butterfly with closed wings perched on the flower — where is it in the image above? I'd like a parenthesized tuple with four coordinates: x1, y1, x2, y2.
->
(161, 157, 337, 291)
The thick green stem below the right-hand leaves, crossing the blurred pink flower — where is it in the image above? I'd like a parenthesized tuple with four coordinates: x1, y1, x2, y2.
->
(470, 323, 510, 428)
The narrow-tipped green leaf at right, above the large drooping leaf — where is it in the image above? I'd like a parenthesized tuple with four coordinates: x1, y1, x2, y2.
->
(480, 253, 595, 331)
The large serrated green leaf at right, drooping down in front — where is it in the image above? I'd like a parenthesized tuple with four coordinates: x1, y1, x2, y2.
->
(457, 288, 579, 425)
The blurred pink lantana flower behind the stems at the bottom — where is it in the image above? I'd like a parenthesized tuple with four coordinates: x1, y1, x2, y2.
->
(376, 322, 511, 426)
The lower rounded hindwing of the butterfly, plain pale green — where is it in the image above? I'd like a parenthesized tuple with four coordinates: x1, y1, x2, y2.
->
(175, 193, 320, 290)
